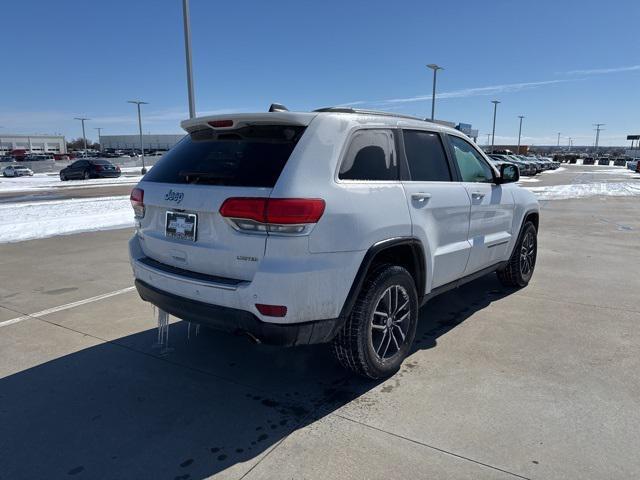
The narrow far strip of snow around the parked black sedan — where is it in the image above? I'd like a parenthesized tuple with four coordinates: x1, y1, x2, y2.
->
(0, 169, 142, 192)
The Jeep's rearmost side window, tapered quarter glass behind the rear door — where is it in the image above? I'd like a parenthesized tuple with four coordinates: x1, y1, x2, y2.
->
(338, 129, 398, 181)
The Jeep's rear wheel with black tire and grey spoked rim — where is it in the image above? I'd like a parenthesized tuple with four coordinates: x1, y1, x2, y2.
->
(333, 264, 418, 379)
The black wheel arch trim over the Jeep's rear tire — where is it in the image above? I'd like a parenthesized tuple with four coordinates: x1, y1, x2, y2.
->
(340, 237, 427, 318)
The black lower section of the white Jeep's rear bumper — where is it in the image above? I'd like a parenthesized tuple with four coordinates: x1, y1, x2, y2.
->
(135, 280, 342, 346)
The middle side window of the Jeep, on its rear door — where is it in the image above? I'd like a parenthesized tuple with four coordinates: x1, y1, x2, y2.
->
(402, 130, 451, 182)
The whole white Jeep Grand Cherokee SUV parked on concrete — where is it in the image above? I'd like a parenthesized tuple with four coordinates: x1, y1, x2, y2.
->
(129, 108, 539, 378)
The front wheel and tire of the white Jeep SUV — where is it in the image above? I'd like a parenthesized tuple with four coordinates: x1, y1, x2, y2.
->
(497, 222, 538, 288)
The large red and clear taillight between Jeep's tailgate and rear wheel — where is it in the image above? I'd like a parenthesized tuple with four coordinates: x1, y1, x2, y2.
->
(220, 197, 325, 234)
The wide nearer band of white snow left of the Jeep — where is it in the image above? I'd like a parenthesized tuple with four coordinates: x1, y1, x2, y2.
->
(0, 196, 134, 243)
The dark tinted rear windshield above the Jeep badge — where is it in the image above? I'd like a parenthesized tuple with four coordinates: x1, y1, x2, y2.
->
(144, 125, 305, 188)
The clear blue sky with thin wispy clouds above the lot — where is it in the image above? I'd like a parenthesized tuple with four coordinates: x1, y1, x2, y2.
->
(0, 0, 640, 145)
